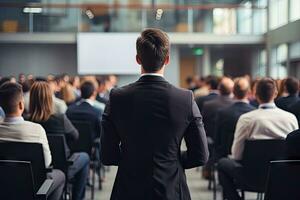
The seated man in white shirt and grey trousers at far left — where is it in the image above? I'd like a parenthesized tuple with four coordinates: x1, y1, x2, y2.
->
(0, 82, 65, 200)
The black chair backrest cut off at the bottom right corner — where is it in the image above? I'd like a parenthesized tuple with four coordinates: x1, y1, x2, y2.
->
(265, 160, 300, 200)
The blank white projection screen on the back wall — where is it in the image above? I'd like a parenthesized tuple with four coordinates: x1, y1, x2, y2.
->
(77, 33, 140, 75)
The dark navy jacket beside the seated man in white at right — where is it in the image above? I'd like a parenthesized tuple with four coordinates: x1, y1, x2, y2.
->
(214, 101, 255, 159)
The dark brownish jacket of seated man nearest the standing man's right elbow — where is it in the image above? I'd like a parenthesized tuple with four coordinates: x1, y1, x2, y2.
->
(202, 96, 234, 139)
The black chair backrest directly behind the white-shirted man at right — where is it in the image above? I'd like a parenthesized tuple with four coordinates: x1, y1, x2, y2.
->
(242, 139, 285, 192)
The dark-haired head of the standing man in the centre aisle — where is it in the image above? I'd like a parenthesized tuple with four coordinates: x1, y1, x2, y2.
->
(136, 29, 170, 73)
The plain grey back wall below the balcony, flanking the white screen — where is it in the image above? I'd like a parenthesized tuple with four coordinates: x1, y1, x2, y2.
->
(0, 43, 179, 86)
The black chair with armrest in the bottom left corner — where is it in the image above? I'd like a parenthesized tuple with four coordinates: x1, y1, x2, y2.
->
(0, 160, 53, 200)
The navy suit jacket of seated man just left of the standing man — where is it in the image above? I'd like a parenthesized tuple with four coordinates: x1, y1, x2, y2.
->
(66, 101, 102, 139)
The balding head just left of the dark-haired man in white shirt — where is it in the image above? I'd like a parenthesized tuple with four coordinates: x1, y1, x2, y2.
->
(233, 78, 250, 100)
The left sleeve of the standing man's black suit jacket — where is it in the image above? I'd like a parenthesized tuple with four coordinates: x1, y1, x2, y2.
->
(100, 92, 121, 165)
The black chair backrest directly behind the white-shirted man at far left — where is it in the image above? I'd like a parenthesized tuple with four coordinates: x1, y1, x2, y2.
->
(0, 142, 46, 192)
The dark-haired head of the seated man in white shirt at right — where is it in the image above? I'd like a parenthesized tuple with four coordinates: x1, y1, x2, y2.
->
(256, 78, 277, 103)
